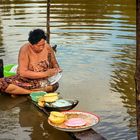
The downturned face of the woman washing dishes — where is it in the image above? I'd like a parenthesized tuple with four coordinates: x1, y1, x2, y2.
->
(32, 39, 45, 53)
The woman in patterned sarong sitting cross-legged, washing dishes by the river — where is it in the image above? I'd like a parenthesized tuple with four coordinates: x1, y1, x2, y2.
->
(0, 29, 61, 94)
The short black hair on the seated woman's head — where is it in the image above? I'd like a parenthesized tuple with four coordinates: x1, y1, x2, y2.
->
(28, 29, 47, 45)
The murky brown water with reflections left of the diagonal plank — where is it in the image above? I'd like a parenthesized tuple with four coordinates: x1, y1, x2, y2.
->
(0, 95, 71, 140)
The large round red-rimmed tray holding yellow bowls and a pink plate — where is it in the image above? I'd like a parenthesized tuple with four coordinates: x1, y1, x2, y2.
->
(48, 111, 99, 132)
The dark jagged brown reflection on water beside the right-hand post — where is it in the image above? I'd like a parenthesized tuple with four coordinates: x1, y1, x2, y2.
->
(110, 45, 136, 123)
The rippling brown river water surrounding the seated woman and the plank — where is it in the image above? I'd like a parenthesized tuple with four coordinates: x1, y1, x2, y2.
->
(0, 0, 137, 140)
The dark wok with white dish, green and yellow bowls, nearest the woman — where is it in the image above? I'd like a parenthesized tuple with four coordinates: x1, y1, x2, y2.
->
(30, 91, 78, 111)
